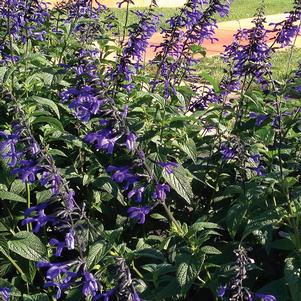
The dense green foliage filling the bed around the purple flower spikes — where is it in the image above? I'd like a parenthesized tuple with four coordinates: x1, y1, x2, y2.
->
(0, 0, 301, 301)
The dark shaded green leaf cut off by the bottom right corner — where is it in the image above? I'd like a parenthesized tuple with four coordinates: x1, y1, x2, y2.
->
(284, 257, 301, 301)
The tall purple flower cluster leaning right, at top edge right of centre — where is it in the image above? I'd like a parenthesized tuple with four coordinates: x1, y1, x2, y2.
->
(153, 0, 231, 98)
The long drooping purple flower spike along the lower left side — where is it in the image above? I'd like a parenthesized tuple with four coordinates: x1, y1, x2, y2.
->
(0, 96, 102, 299)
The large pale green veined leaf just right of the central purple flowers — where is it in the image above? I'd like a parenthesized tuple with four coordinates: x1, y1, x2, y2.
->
(162, 166, 193, 204)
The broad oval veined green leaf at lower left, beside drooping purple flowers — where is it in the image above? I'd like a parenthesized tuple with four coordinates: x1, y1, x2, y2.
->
(8, 231, 47, 261)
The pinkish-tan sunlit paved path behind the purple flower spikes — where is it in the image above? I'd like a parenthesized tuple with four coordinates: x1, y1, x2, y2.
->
(146, 14, 301, 60)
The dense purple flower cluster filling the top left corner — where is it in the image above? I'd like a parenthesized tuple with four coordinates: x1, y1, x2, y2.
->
(0, 0, 50, 63)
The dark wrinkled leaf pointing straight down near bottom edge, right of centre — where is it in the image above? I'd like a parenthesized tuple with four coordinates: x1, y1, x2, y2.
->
(176, 253, 205, 294)
